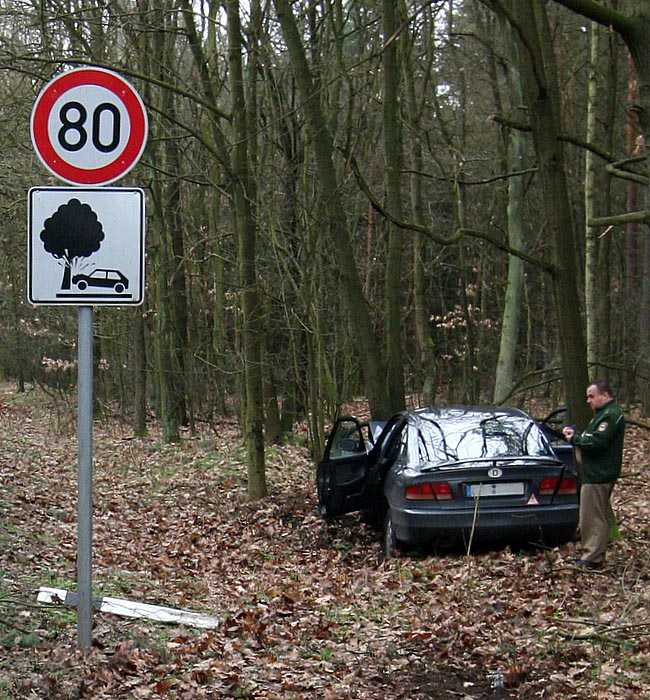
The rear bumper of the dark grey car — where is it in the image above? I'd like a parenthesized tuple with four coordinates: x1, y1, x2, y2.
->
(391, 504, 578, 545)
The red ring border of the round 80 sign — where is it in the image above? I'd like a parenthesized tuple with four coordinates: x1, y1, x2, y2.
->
(31, 68, 148, 185)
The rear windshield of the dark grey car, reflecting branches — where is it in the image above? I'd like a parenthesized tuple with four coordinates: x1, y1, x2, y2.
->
(408, 411, 553, 463)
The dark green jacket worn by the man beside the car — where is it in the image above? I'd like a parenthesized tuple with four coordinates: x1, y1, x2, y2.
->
(571, 400, 625, 484)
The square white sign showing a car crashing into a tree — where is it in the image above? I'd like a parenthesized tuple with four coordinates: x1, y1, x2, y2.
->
(27, 187, 145, 306)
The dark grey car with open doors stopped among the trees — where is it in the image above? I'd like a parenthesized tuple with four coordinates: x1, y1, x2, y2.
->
(317, 406, 578, 556)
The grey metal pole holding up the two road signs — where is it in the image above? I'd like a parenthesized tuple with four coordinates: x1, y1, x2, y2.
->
(77, 306, 93, 649)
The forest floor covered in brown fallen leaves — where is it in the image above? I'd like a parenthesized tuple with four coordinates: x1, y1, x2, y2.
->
(0, 385, 650, 700)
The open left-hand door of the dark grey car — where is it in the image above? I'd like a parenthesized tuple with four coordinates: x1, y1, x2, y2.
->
(316, 416, 372, 518)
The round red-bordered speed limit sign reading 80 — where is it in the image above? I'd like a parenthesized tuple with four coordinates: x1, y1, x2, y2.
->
(31, 68, 148, 185)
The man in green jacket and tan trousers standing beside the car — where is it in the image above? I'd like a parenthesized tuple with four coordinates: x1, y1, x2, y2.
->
(563, 380, 625, 569)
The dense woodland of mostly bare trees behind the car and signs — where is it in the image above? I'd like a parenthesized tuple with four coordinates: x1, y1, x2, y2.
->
(0, 0, 650, 499)
